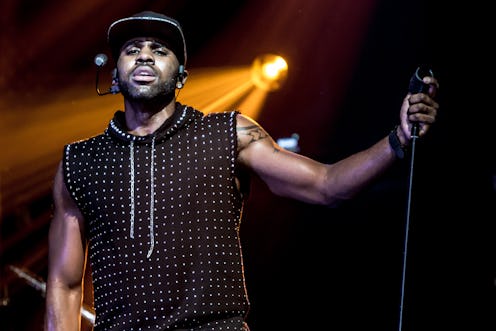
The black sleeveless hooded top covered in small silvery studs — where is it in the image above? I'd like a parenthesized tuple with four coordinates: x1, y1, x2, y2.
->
(63, 103, 249, 331)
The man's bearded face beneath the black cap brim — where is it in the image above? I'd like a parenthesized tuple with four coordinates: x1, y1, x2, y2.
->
(117, 38, 179, 100)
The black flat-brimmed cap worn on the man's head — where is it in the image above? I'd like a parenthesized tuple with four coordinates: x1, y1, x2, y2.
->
(107, 11, 187, 66)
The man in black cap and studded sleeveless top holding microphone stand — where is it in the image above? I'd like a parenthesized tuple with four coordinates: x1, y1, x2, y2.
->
(46, 12, 438, 331)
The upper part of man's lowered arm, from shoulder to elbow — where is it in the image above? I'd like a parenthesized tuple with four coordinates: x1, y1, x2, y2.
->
(48, 166, 86, 287)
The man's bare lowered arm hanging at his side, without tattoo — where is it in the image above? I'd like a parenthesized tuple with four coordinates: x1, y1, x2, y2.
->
(45, 165, 86, 331)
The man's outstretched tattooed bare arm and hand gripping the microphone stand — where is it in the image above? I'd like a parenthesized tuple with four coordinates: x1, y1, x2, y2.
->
(237, 78, 438, 206)
